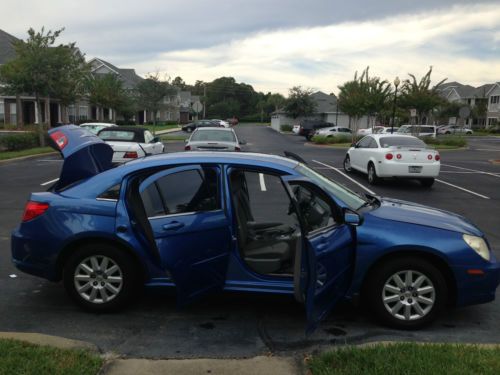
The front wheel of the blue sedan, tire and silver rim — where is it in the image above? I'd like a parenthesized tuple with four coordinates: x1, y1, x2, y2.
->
(363, 256, 448, 330)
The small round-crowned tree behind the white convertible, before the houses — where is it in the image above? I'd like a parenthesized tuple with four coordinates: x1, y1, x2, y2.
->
(136, 73, 175, 130)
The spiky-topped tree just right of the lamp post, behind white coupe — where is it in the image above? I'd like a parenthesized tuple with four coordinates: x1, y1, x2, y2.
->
(398, 66, 446, 124)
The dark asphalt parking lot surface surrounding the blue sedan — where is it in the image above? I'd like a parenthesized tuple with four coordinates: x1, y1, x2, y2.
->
(0, 125, 500, 358)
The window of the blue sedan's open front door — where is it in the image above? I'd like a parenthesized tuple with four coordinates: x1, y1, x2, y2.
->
(291, 183, 336, 233)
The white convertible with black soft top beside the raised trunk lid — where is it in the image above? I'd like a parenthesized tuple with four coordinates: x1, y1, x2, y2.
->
(97, 126, 165, 164)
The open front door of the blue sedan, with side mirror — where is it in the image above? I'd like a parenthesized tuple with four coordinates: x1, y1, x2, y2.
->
(289, 181, 355, 333)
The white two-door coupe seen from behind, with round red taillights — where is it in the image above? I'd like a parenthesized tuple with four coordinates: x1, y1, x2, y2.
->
(344, 134, 441, 187)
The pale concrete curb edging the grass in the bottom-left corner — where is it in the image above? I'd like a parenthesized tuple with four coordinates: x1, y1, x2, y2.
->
(0, 332, 99, 353)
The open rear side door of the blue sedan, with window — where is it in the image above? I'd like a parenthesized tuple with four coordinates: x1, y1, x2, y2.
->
(139, 165, 231, 305)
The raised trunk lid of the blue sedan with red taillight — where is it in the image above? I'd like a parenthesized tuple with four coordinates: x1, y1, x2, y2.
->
(49, 125, 113, 189)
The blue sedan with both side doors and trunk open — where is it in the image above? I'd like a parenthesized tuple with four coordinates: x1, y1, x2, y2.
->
(12, 125, 500, 331)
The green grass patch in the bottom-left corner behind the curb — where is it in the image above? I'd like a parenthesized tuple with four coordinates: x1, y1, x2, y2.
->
(0, 339, 103, 375)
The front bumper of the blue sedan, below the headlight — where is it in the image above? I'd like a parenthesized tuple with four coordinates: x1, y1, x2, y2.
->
(453, 262, 500, 306)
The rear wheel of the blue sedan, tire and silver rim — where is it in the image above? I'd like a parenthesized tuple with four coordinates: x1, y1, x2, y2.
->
(63, 243, 140, 312)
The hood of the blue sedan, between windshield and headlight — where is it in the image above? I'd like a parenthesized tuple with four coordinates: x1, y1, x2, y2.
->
(370, 198, 483, 236)
